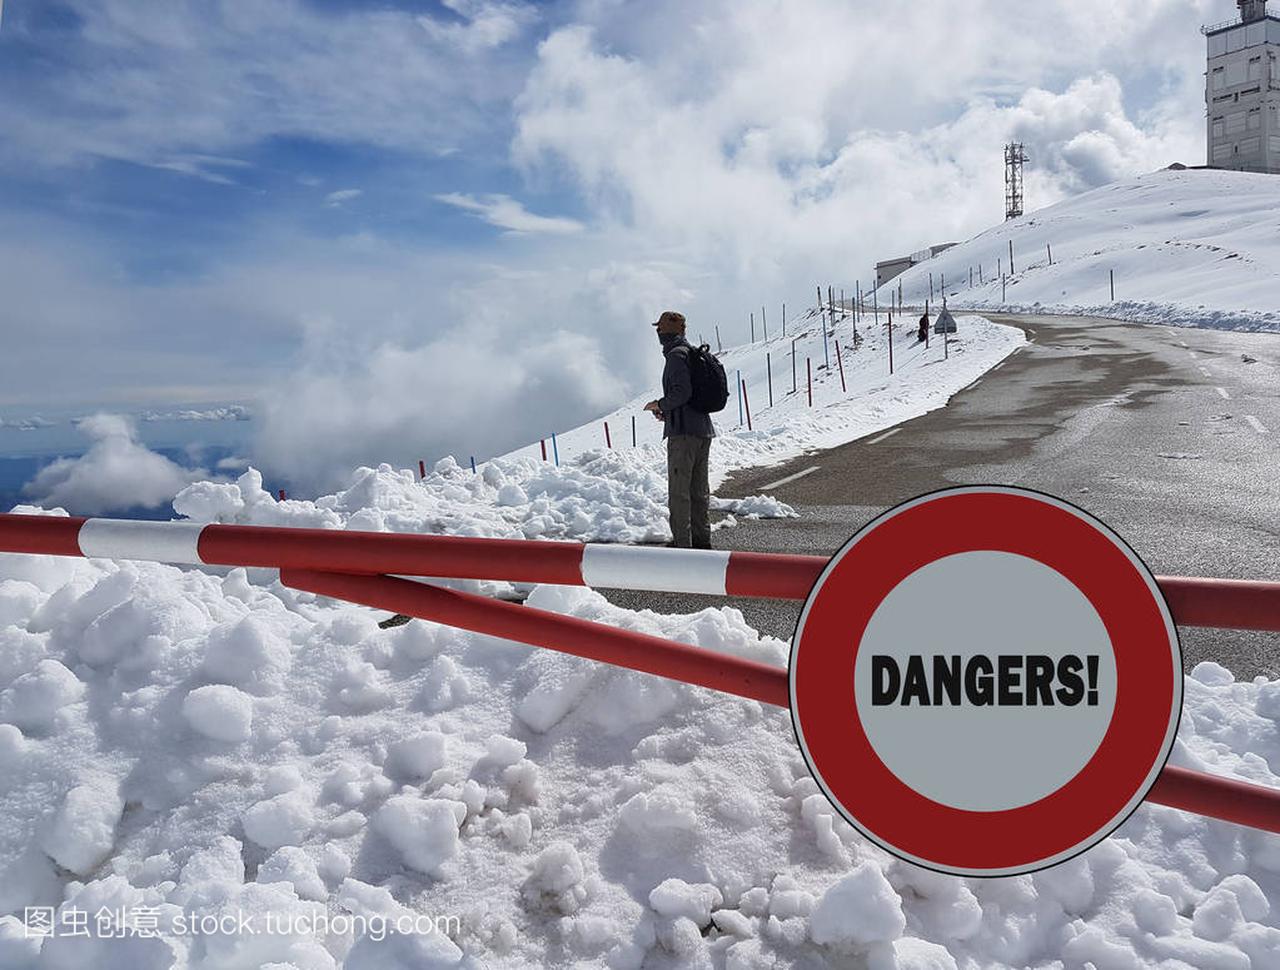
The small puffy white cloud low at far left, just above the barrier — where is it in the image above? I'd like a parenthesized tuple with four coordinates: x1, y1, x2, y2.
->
(23, 413, 207, 516)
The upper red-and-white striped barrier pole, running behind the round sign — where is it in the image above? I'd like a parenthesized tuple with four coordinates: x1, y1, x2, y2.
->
(0, 514, 1280, 632)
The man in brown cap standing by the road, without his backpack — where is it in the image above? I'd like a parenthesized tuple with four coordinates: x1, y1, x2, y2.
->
(645, 310, 716, 549)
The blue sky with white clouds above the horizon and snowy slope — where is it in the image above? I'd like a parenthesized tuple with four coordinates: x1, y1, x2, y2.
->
(0, 0, 1233, 479)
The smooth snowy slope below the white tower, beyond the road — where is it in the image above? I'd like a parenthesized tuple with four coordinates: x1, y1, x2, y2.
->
(881, 170, 1280, 330)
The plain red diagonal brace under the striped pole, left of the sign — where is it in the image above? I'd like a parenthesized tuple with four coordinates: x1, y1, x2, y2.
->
(280, 569, 790, 708)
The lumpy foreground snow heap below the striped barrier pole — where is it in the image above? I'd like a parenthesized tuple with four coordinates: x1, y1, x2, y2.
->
(0, 527, 1280, 970)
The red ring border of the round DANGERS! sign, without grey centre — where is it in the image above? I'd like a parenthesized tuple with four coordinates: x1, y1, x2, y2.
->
(788, 485, 1183, 877)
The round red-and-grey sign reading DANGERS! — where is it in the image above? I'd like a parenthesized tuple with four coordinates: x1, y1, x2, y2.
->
(791, 486, 1183, 875)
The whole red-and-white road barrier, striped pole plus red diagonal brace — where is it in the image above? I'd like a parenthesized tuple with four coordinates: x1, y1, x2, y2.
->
(0, 514, 1280, 833)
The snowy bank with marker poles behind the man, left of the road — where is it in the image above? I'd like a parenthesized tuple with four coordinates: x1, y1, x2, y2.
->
(507, 308, 1027, 478)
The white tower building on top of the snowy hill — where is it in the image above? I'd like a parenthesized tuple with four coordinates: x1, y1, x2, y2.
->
(1203, 0, 1280, 174)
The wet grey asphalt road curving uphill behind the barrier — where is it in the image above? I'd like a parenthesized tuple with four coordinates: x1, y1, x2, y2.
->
(609, 316, 1280, 678)
